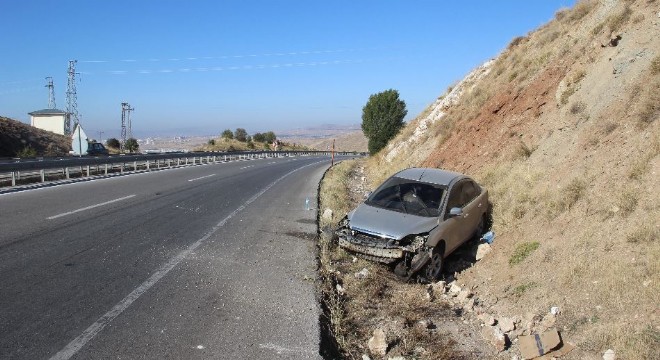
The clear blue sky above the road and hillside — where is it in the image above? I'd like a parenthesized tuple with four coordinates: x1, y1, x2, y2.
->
(0, 0, 574, 138)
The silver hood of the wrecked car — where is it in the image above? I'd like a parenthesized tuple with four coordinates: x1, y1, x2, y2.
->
(348, 203, 438, 240)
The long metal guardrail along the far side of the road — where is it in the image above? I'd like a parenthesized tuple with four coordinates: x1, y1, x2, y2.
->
(0, 151, 359, 187)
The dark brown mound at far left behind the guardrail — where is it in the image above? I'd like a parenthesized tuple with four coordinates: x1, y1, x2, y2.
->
(0, 116, 71, 157)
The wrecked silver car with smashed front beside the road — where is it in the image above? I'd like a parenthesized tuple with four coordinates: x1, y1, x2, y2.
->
(336, 168, 490, 281)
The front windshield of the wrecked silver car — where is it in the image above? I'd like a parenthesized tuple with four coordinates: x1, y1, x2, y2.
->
(365, 177, 444, 217)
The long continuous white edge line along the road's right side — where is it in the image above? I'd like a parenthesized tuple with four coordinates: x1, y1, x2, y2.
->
(50, 160, 326, 360)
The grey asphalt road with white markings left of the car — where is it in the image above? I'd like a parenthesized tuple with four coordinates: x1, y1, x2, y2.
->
(0, 157, 340, 359)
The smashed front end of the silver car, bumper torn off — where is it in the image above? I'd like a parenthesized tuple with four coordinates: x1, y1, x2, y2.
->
(336, 215, 428, 273)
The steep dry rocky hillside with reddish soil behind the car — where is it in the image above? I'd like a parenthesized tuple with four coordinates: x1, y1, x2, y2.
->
(366, 0, 660, 359)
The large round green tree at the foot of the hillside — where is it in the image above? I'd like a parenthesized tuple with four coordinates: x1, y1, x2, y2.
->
(362, 89, 408, 155)
